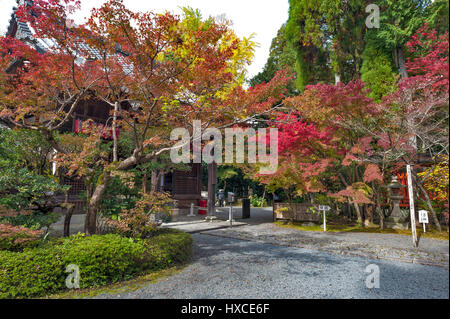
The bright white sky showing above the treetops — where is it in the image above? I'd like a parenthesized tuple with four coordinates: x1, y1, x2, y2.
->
(0, 0, 289, 78)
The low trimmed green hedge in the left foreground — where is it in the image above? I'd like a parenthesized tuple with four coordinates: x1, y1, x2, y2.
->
(0, 229, 192, 298)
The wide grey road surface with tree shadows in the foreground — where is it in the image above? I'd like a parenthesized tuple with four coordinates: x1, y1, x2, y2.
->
(97, 234, 449, 299)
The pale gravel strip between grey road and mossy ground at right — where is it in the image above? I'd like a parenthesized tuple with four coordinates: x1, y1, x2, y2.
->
(208, 223, 449, 269)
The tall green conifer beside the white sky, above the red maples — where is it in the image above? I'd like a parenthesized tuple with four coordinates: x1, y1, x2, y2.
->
(286, 0, 368, 90)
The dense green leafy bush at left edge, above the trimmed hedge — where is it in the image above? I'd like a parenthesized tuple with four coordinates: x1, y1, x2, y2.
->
(0, 128, 67, 229)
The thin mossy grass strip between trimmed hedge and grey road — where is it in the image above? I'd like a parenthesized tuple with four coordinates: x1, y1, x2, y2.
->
(37, 265, 186, 299)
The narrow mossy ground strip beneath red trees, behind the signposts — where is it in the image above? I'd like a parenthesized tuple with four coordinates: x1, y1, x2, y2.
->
(275, 220, 449, 240)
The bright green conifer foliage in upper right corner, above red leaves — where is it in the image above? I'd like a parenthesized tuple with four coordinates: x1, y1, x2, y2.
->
(361, 0, 442, 101)
